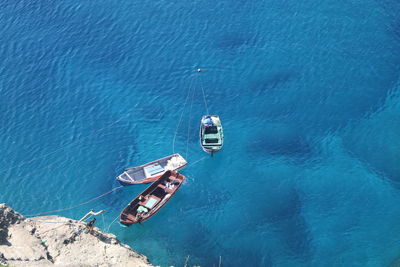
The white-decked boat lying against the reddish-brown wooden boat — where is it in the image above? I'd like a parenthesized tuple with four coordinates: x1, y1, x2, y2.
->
(116, 153, 187, 185)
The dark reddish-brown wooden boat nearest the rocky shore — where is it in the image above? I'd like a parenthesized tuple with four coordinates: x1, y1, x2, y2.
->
(119, 171, 186, 226)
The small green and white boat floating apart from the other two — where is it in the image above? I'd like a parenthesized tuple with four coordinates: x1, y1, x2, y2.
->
(200, 115, 224, 154)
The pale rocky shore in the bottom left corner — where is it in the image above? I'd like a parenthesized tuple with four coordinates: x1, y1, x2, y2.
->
(0, 204, 153, 267)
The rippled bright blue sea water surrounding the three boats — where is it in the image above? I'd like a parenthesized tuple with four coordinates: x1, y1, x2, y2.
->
(0, 0, 400, 266)
